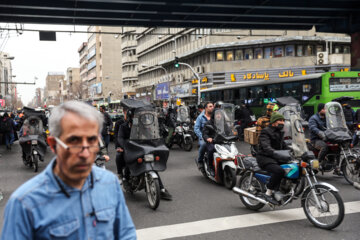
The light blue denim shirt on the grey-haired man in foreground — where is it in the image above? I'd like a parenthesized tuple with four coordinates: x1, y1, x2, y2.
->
(1, 159, 136, 240)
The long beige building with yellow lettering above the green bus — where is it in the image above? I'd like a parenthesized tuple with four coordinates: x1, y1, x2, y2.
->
(135, 28, 351, 102)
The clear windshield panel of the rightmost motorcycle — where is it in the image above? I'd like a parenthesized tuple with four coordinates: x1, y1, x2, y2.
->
(325, 102, 347, 129)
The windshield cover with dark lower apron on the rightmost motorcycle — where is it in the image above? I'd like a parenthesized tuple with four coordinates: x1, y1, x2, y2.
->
(325, 102, 352, 142)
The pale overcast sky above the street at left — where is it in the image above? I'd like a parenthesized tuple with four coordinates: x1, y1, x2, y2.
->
(0, 23, 87, 105)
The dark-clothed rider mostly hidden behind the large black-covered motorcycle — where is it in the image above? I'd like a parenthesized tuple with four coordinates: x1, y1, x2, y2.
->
(116, 108, 172, 200)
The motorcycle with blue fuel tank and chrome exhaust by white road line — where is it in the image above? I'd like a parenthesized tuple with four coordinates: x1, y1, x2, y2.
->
(233, 111, 344, 229)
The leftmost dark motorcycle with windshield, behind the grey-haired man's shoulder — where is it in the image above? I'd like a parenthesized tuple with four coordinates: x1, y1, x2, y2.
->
(19, 116, 47, 172)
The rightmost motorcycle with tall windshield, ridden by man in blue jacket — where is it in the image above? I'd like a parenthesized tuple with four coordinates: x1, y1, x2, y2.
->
(308, 102, 360, 185)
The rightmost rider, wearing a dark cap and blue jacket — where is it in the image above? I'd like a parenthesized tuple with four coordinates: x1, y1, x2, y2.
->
(309, 103, 341, 175)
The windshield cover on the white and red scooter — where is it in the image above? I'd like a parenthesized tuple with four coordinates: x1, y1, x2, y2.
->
(214, 109, 237, 142)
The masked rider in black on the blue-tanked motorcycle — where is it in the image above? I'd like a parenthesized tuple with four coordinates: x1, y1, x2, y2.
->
(256, 113, 286, 204)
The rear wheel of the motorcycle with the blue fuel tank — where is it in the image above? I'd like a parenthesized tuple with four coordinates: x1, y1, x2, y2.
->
(239, 172, 265, 210)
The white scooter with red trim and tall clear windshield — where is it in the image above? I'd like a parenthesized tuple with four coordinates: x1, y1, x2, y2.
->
(200, 109, 238, 189)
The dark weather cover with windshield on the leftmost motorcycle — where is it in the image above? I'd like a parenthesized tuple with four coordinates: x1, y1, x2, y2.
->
(19, 116, 46, 157)
